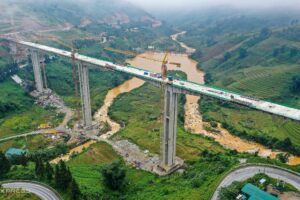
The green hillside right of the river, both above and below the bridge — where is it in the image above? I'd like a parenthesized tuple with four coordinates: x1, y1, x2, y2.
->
(173, 8, 300, 154)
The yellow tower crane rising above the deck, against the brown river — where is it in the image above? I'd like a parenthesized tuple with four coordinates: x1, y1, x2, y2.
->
(104, 47, 181, 79)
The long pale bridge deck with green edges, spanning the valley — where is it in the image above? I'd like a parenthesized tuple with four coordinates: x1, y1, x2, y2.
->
(14, 41, 300, 121)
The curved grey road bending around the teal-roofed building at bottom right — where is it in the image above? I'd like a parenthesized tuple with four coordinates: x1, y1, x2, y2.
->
(212, 166, 300, 200)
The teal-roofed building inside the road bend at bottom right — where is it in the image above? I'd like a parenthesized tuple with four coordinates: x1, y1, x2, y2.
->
(242, 183, 279, 200)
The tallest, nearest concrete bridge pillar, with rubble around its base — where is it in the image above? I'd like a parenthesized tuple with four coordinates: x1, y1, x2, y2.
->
(160, 85, 178, 170)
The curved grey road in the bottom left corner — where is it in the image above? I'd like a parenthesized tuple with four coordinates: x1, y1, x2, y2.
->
(2, 182, 60, 200)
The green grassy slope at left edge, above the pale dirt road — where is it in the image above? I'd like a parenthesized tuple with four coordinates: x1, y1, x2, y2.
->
(0, 79, 61, 138)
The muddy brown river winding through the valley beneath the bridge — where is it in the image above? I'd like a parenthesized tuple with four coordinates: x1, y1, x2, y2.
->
(94, 32, 300, 165)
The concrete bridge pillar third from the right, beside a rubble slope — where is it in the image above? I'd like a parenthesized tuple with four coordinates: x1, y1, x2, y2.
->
(31, 50, 44, 92)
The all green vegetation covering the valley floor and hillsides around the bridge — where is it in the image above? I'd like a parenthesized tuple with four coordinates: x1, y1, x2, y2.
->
(0, 1, 300, 200)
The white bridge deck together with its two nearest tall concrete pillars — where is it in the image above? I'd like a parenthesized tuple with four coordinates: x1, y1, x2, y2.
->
(8, 41, 300, 173)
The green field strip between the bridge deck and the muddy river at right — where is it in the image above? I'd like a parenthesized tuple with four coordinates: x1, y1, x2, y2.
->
(199, 98, 300, 155)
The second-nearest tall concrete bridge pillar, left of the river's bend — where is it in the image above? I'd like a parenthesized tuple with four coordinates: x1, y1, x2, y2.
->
(78, 63, 92, 127)
